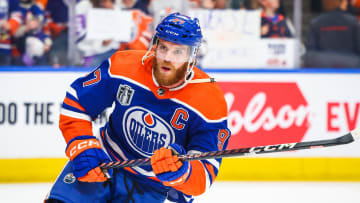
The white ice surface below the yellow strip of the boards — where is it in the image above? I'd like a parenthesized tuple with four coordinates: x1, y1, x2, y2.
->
(0, 181, 360, 203)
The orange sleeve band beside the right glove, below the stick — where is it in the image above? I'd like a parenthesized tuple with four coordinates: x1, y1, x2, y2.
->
(174, 161, 206, 196)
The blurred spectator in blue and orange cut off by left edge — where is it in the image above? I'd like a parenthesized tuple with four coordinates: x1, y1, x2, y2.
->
(0, 0, 22, 65)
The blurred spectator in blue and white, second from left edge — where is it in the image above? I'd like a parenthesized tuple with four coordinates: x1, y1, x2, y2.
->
(13, 0, 52, 66)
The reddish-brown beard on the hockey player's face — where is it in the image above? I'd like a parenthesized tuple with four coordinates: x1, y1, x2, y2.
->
(153, 60, 188, 86)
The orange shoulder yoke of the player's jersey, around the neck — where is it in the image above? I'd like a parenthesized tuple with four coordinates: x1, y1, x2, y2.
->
(110, 50, 227, 120)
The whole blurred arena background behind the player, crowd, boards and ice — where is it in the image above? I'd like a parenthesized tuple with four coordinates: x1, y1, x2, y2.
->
(0, 0, 360, 202)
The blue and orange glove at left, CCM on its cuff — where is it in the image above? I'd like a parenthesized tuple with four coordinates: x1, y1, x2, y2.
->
(66, 135, 112, 182)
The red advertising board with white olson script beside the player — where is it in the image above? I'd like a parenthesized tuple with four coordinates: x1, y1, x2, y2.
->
(219, 82, 310, 149)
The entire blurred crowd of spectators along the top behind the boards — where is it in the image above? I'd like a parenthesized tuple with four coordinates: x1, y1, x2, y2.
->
(0, 0, 360, 67)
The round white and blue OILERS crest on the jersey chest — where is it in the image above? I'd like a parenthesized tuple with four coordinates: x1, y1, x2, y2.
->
(123, 106, 175, 157)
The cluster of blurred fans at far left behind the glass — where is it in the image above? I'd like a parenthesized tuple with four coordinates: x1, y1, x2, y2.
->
(0, 0, 68, 66)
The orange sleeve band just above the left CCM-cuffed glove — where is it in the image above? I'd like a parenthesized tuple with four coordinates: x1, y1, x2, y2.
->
(59, 115, 93, 143)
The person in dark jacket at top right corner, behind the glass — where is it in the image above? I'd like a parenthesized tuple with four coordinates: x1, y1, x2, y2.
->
(304, 0, 360, 68)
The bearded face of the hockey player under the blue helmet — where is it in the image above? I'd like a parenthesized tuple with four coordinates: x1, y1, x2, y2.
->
(154, 39, 190, 87)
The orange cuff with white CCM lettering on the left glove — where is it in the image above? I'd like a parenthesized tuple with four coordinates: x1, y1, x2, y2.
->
(66, 138, 101, 161)
